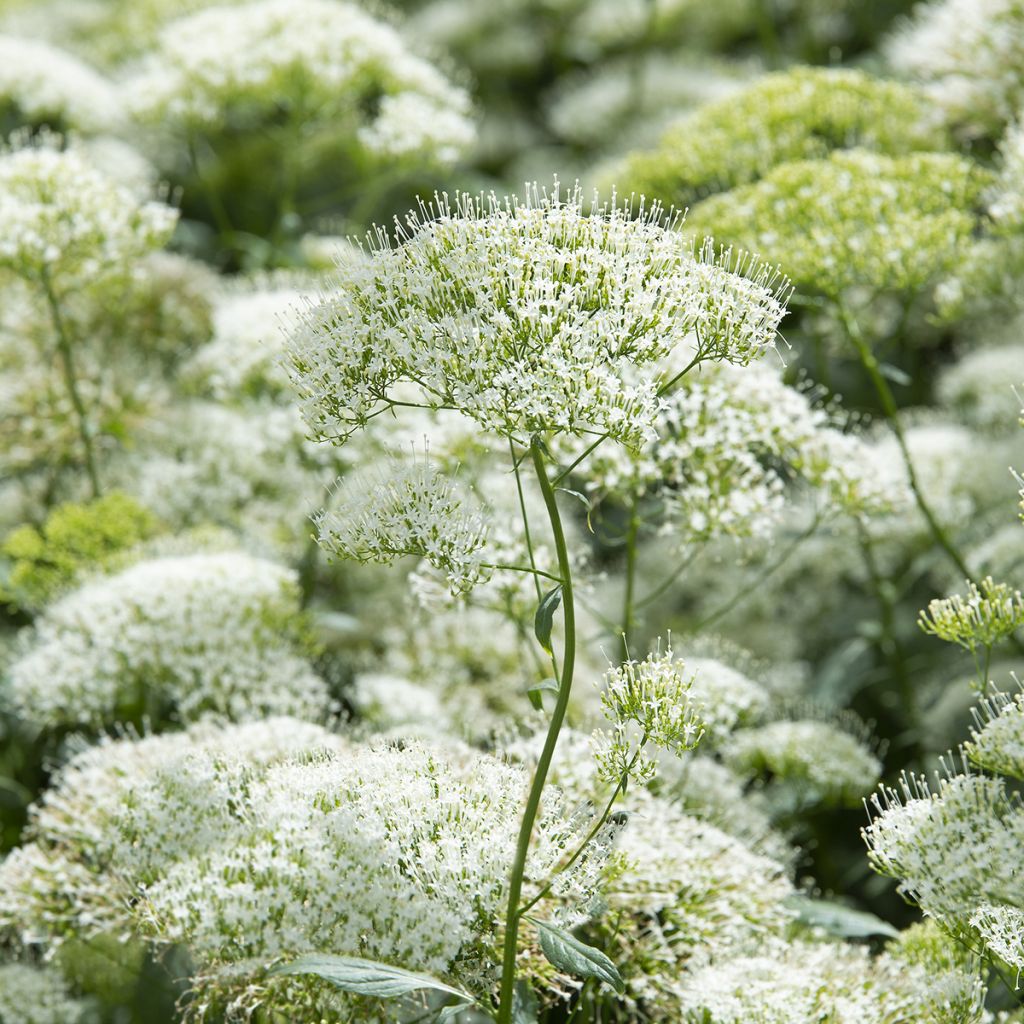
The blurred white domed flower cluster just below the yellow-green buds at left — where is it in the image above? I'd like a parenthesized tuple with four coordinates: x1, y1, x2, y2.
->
(8, 552, 330, 727)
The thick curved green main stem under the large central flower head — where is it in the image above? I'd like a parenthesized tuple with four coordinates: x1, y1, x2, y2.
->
(498, 441, 575, 1024)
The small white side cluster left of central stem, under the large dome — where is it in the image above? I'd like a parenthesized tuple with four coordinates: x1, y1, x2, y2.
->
(315, 456, 490, 594)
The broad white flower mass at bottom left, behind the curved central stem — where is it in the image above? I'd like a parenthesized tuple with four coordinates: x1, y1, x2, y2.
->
(0, 719, 589, 1020)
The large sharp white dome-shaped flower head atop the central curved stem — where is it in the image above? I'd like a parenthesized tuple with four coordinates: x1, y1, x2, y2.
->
(290, 187, 784, 444)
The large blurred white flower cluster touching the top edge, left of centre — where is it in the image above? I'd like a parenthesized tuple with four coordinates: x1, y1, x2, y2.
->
(127, 0, 474, 164)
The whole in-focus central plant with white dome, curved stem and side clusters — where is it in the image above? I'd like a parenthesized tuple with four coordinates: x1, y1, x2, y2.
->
(285, 185, 784, 1024)
